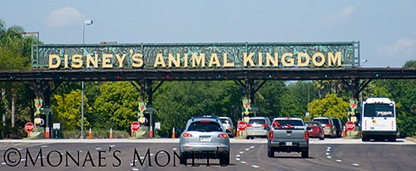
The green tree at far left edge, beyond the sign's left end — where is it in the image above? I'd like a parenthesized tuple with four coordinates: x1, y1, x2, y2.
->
(0, 20, 37, 136)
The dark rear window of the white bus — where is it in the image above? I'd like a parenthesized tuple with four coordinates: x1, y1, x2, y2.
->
(364, 104, 394, 117)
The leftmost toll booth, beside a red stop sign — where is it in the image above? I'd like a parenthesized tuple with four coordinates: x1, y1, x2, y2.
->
(30, 107, 53, 138)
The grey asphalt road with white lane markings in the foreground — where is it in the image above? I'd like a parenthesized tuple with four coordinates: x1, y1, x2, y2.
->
(0, 139, 416, 171)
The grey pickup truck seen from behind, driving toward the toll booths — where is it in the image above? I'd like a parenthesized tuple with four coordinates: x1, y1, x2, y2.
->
(267, 117, 310, 158)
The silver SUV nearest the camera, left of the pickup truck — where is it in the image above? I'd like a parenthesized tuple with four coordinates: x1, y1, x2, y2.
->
(179, 116, 230, 166)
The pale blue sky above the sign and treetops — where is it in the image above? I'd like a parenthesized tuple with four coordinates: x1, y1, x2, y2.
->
(0, 0, 416, 68)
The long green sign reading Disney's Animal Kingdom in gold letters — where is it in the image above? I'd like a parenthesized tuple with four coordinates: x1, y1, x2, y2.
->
(32, 42, 359, 70)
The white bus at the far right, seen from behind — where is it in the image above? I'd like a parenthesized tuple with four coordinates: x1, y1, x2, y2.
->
(361, 98, 397, 141)
